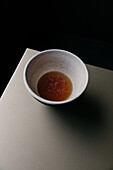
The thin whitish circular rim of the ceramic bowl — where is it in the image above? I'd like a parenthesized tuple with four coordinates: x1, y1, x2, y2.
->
(23, 49, 89, 105)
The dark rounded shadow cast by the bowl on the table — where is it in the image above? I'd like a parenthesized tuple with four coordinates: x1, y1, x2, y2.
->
(52, 93, 106, 136)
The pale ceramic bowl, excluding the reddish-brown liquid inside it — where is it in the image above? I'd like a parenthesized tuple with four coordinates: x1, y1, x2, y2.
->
(23, 49, 88, 105)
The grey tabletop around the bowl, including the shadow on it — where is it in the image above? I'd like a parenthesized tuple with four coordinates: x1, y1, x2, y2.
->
(0, 49, 113, 170)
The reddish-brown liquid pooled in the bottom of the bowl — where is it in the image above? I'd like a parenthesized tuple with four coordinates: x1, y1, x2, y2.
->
(37, 72, 72, 101)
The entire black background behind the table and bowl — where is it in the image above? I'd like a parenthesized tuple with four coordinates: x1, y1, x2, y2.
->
(0, 0, 113, 93)
